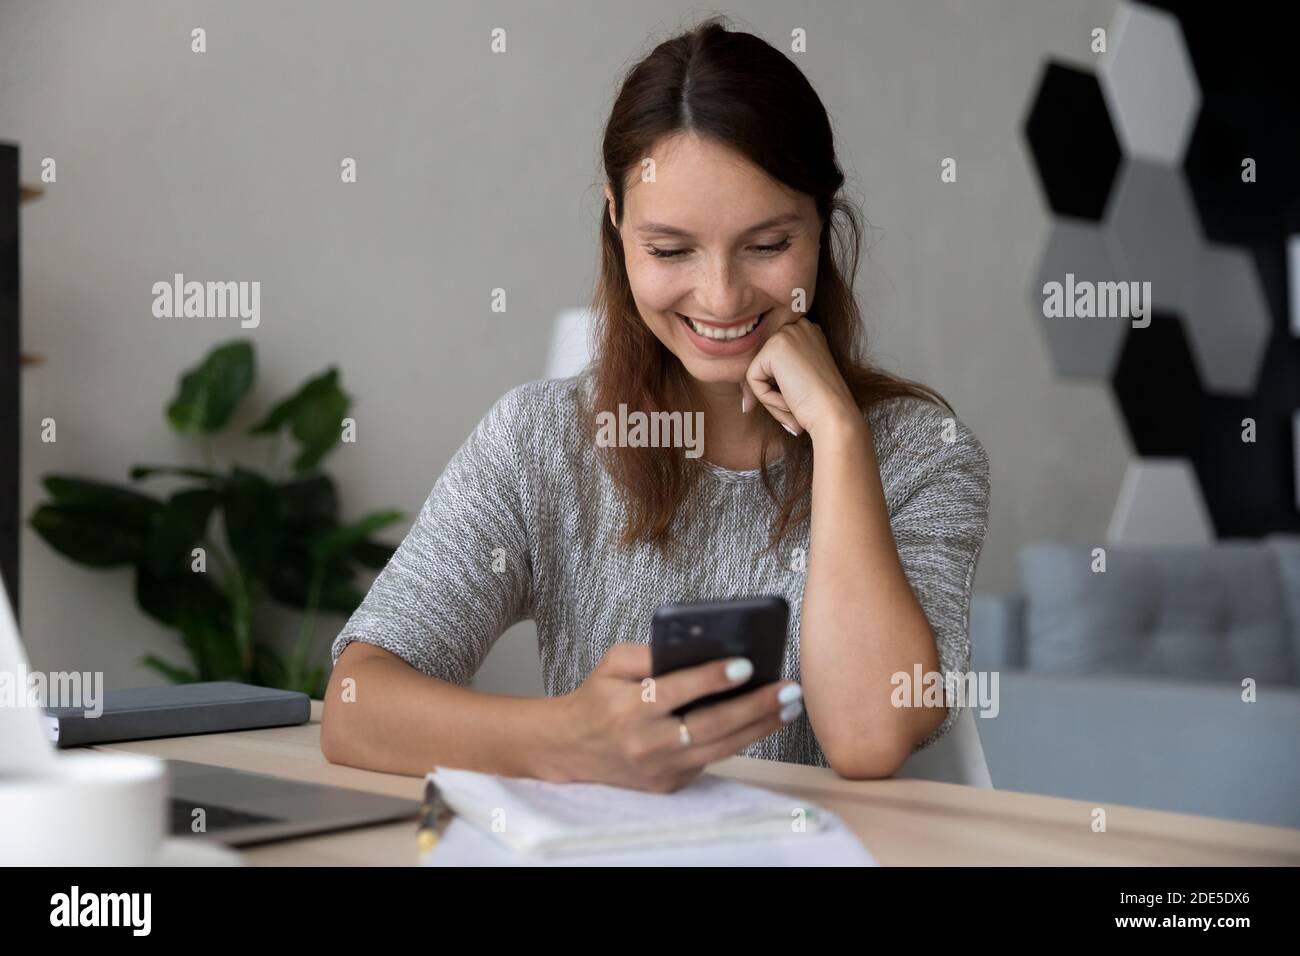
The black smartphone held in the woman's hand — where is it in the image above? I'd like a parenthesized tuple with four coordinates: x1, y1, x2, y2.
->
(650, 596, 790, 717)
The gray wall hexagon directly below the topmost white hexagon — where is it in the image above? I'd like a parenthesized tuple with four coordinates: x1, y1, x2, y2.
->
(1102, 159, 1203, 312)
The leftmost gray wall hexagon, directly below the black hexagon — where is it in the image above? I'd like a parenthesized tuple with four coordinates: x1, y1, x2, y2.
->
(1030, 219, 1130, 380)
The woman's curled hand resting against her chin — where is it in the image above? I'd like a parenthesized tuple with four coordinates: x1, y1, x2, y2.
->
(740, 316, 862, 438)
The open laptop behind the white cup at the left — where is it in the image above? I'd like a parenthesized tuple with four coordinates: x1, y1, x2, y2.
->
(0, 580, 420, 847)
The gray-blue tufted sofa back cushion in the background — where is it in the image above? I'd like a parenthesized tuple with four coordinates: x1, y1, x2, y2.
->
(1019, 540, 1300, 684)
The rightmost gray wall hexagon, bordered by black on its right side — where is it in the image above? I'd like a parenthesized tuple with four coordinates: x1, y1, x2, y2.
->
(1183, 245, 1273, 395)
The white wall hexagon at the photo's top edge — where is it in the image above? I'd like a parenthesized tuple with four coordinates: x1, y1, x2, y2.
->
(1099, 3, 1196, 166)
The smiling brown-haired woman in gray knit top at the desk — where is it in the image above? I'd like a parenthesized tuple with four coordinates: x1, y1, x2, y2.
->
(321, 20, 989, 791)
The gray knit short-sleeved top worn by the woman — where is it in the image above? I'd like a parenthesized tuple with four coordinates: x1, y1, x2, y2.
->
(332, 376, 989, 766)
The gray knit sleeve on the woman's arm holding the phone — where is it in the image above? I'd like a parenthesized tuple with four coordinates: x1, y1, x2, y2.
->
(330, 389, 532, 685)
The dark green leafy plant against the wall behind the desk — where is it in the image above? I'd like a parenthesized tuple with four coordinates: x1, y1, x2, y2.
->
(30, 341, 402, 697)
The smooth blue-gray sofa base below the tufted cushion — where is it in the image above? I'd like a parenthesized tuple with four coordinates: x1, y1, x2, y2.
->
(977, 672, 1300, 832)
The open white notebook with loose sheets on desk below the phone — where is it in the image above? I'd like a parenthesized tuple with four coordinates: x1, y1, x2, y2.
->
(429, 767, 874, 865)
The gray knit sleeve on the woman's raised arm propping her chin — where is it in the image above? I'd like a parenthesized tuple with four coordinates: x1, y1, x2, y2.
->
(881, 398, 989, 750)
